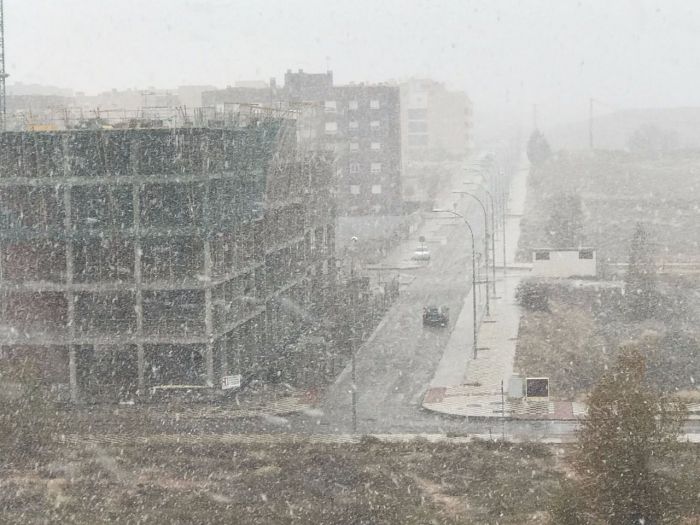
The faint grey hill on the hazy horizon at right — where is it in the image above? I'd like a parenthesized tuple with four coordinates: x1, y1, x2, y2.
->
(543, 107, 700, 150)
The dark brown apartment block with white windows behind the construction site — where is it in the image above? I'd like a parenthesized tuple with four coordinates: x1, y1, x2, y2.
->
(203, 70, 403, 217)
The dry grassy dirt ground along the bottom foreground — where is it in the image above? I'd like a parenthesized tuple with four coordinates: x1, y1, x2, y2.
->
(0, 439, 562, 525)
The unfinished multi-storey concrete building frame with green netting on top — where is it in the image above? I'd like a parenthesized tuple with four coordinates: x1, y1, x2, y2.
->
(0, 108, 335, 401)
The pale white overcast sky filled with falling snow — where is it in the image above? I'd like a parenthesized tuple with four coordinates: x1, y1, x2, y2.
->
(4, 0, 700, 125)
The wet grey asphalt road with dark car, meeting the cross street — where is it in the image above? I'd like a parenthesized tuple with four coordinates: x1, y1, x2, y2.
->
(276, 163, 576, 439)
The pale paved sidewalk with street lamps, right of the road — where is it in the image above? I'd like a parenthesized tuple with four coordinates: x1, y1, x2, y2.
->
(423, 158, 586, 420)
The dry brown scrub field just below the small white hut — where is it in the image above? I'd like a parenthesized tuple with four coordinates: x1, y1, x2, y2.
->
(515, 278, 700, 399)
